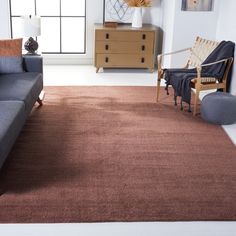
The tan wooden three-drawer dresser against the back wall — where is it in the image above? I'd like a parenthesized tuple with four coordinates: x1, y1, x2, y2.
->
(95, 24, 157, 72)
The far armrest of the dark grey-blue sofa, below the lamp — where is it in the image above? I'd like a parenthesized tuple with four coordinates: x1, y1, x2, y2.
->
(23, 55, 43, 73)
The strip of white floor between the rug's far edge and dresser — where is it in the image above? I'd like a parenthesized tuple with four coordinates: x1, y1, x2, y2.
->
(44, 65, 156, 86)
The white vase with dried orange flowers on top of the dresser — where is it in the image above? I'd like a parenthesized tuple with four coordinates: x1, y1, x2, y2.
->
(125, 0, 151, 28)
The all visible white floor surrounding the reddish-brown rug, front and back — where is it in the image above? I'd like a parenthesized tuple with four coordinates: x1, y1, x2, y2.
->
(0, 66, 236, 236)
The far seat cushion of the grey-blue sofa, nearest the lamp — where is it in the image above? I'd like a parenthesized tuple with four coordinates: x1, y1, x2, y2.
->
(0, 72, 43, 113)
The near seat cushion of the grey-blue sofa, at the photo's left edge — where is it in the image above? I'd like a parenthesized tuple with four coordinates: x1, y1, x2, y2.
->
(0, 101, 26, 168)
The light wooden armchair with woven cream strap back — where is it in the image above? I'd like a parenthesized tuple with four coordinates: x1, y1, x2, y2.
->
(157, 37, 233, 116)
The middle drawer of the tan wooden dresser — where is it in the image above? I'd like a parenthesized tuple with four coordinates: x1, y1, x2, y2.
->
(95, 41, 154, 53)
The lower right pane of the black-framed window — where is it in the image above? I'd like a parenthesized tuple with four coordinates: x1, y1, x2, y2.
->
(61, 17, 85, 53)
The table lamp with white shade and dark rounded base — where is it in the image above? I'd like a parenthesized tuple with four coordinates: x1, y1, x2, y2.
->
(21, 15, 41, 54)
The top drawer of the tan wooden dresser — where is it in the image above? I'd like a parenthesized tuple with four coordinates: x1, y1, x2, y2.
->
(96, 30, 155, 43)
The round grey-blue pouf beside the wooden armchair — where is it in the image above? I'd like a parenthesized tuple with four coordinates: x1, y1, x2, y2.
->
(201, 92, 236, 125)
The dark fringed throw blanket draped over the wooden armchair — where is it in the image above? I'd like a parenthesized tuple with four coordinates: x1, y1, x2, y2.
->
(164, 41, 235, 107)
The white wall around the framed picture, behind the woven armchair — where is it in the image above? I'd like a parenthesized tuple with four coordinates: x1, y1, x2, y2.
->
(163, 0, 219, 67)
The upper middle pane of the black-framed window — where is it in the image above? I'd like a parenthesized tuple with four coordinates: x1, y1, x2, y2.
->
(36, 0, 60, 16)
